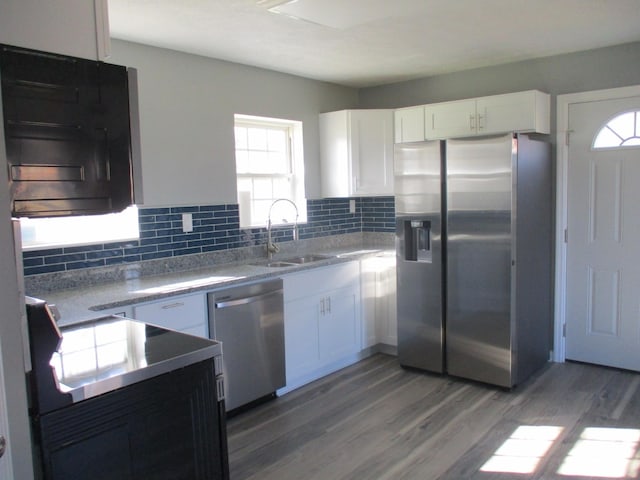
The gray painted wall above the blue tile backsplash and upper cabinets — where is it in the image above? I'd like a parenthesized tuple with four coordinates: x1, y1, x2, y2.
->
(109, 40, 640, 206)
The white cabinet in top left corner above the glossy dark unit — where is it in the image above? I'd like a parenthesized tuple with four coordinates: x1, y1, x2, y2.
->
(0, 0, 111, 60)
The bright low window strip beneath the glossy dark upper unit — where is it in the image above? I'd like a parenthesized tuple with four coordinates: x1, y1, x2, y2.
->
(20, 205, 140, 250)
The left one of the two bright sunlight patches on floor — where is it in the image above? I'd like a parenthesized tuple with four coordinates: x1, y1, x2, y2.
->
(480, 425, 563, 474)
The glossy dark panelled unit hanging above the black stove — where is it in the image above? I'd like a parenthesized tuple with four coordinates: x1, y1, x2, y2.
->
(0, 45, 134, 217)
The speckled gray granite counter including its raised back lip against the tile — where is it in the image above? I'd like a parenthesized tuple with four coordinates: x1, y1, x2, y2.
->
(25, 234, 393, 325)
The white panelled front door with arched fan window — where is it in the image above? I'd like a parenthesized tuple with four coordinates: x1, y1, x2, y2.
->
(566, 97, 640, 370)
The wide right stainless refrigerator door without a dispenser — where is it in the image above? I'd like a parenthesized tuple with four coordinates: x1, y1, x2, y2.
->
(446, 135, 514, 387)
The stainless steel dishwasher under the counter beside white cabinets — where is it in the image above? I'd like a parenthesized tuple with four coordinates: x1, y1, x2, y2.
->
(207, 279, 286, 411)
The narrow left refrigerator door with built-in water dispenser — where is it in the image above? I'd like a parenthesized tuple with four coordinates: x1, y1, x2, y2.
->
(394, 142, 444, 372)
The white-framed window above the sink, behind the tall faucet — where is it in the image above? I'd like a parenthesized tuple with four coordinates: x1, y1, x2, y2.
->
(235, 115, 307, 228)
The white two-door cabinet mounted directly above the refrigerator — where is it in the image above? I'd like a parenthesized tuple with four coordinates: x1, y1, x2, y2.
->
(424, 90, 550, 140)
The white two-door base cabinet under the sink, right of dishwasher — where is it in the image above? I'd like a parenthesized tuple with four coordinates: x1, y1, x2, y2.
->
(283, 262, 361, 391)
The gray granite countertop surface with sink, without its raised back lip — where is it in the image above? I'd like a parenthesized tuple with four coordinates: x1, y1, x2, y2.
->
(27, 239, 393, 325)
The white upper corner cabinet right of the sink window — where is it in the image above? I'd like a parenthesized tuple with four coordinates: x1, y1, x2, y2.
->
(320, 110, 393, 197)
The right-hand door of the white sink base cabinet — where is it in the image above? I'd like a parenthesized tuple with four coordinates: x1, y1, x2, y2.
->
(318, 288, 360, 363)
